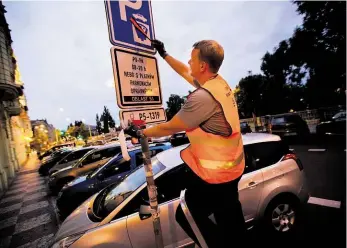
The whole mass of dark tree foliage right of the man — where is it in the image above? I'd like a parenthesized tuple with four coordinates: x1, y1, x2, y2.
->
(236, 1, 346, 117)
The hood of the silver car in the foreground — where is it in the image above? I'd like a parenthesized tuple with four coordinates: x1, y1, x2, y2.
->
(54, 194, 100, 242)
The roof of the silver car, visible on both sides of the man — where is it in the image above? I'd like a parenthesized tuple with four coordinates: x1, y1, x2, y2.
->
(157, 133, 281, 168)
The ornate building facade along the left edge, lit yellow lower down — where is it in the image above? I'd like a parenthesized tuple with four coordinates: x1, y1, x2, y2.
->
(0, 1, 31, 195)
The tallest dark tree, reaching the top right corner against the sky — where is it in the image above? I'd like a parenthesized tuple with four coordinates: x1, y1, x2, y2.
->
(261, 1, 346, 107)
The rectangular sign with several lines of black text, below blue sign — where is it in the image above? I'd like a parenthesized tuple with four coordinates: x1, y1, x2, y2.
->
(111, 47, 162, 109)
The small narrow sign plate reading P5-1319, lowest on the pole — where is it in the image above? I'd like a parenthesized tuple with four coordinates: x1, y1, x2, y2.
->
(119, 108, 167, 124)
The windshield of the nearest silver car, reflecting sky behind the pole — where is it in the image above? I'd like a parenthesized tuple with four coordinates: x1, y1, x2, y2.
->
(94, 157, 165, 218)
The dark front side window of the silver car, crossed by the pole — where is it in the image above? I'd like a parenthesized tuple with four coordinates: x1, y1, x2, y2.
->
(115, 164, 187, 219)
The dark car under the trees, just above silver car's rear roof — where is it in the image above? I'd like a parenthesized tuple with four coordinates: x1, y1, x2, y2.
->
(271, 113, 310, 138)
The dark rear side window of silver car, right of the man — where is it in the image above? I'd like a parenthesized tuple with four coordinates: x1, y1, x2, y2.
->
(245, 141, 289, 172)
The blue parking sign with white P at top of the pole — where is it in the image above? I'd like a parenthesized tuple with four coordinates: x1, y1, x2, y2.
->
(105, 0, 156, 54)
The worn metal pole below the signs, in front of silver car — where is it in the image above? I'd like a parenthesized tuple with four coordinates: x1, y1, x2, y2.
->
(140, 137, 164, 248)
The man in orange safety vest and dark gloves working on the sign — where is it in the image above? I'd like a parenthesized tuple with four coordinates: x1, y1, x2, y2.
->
(125, 40, 246, 248)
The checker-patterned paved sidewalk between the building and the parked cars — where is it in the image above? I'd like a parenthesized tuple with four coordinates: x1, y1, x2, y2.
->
(0, 154, 58, 248)
